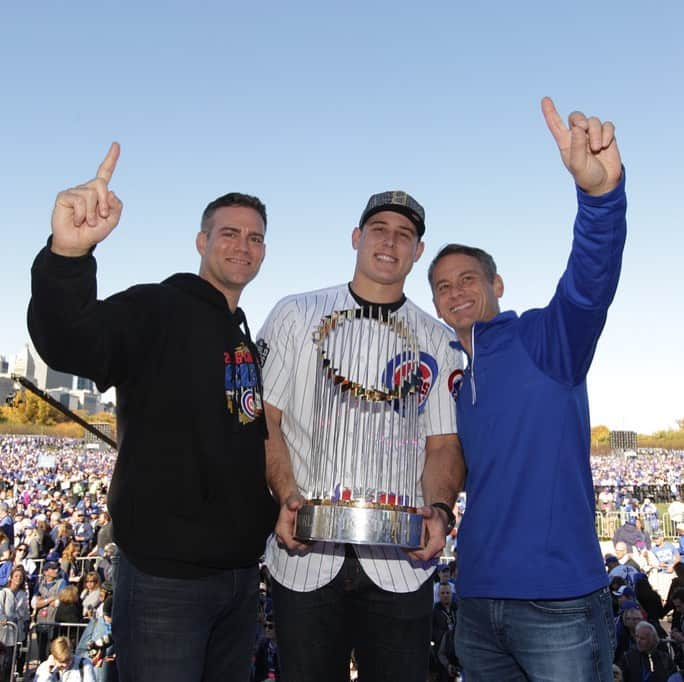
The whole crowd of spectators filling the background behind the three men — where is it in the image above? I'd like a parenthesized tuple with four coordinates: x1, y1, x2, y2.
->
(0, 435, 684, 682)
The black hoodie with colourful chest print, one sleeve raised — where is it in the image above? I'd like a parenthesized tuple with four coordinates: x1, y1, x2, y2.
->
(28, 247, 277, 578)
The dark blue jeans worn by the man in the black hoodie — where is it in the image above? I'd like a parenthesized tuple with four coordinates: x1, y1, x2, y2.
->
(112, 553, 258, 682)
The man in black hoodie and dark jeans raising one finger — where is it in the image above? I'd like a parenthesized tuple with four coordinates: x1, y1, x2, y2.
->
(28, 143, 275, 682)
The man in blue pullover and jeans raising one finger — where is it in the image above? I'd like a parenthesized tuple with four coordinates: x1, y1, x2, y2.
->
(428, 98, 626, 682)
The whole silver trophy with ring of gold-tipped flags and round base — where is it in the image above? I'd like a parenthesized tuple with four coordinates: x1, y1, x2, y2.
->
(295, 306, 423, 548)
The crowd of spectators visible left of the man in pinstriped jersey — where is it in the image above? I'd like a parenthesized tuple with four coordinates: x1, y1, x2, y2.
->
(0, 436, 279, 682)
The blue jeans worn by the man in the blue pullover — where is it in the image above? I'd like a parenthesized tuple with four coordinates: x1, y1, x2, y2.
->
(456, 588, 615, 682)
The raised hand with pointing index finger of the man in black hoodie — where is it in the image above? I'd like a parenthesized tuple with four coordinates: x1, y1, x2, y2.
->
(50, 142, 123, 257)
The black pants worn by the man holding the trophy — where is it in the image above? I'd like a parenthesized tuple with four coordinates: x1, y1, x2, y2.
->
(272, 554, 433, 682)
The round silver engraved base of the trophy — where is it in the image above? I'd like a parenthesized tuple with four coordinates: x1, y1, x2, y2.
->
(295, 500, 423, 549)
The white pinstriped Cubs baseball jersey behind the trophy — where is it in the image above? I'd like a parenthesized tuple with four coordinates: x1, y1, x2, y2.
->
(257, 284, 462, 592)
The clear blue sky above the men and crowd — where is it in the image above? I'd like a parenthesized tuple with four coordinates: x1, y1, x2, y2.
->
(0, 0, 684, 432)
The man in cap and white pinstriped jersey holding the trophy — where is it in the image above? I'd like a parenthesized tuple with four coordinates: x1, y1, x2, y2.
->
(257, 192, 464, 682)
